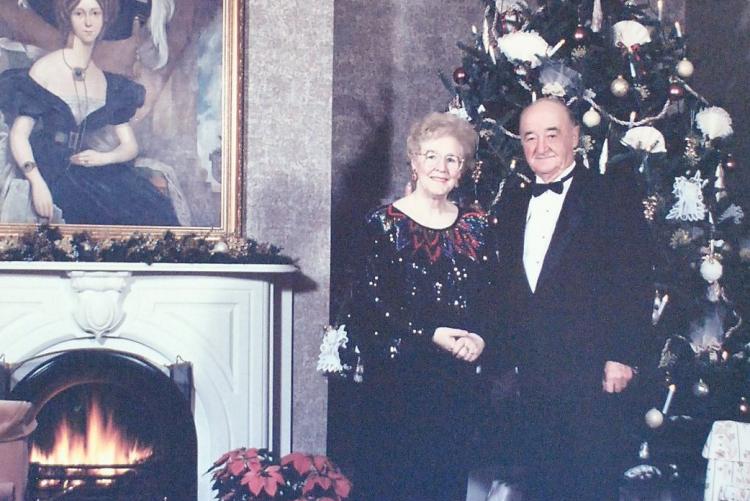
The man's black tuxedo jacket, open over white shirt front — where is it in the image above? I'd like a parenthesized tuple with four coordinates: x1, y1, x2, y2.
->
(488, 165, 653, 402)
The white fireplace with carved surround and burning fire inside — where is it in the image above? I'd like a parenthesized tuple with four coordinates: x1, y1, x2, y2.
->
(0, 263, 295, 501)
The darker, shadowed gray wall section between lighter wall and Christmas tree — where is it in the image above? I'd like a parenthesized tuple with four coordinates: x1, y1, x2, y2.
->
(331, 0, 482, 311)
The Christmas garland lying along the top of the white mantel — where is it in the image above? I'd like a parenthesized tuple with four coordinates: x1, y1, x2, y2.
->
(0, 225, 293, 264)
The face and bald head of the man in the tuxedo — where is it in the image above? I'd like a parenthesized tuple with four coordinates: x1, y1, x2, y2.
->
(520, 100, 578, 183)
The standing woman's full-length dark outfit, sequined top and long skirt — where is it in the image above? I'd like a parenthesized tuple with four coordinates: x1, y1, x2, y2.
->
(338, 205, 492, 501)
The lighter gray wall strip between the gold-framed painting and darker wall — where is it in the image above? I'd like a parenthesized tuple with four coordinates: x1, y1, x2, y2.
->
(245, 0, 333, 452)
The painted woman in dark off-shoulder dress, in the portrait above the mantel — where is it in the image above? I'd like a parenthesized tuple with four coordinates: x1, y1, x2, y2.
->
(0, 0, 179, 226)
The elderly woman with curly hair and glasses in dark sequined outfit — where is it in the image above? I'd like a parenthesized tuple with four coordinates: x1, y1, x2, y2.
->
(323, 113, 491, 501)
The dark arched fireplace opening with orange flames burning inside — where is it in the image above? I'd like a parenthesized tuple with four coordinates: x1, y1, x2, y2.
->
(11, 350, 197, 501)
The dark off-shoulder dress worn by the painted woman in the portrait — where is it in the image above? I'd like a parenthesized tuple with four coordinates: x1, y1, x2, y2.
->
(0, 69, 179, 226)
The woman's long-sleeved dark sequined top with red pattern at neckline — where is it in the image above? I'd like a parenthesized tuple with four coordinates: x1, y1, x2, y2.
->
(339, 205, 491, 376)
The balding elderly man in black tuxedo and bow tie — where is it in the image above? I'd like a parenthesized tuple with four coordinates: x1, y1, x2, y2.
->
(493, 99, 653, 501)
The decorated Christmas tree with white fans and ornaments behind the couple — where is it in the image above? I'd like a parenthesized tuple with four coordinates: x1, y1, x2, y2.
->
(442, 0, 750, 488)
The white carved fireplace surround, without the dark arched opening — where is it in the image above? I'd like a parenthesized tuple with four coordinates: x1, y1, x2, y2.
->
(0, 262, 296, 501)
